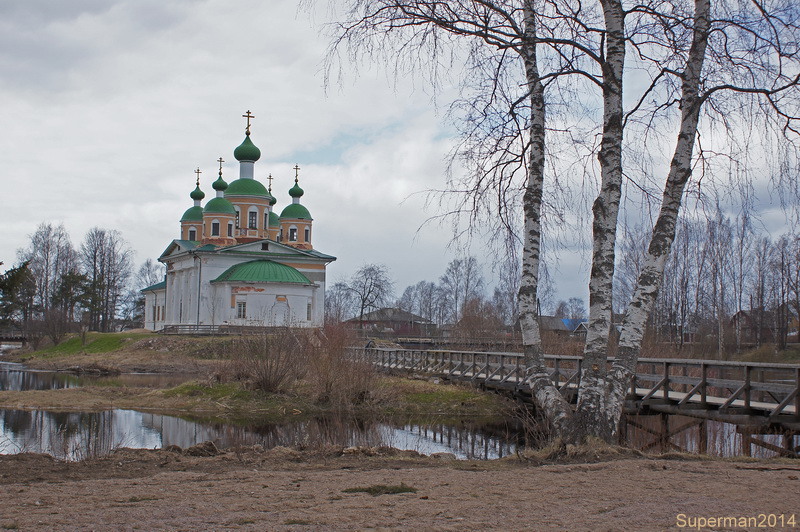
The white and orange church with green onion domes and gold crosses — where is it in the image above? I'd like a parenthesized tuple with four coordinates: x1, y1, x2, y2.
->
(142, 111, 336, 330)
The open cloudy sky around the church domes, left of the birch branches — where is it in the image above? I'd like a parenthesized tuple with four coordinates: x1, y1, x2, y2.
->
(0, 0, 792, 310)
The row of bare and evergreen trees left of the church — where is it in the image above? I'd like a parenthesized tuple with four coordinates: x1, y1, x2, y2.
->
(0, 223, 164, 343)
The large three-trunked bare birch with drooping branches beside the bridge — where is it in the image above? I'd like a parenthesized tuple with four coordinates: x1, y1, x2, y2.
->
(324, 0, 800, 440)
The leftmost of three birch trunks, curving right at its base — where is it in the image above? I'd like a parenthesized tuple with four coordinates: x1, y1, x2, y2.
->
(519, 0, 572, 438)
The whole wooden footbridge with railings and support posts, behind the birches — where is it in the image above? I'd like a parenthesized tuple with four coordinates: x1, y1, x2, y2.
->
(354, 347, 800, 458)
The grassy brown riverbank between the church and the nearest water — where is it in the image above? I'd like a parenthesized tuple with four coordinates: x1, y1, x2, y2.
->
(0, 332, 515, 423)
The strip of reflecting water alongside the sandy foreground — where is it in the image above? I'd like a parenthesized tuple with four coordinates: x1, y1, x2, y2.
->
(0, 410, 516, 460)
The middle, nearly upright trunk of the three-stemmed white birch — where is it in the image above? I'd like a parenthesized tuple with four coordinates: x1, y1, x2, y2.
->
(576, 0, 625, 439)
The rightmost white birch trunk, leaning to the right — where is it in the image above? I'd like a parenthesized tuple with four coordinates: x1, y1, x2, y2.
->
(605, 0, 711, 433)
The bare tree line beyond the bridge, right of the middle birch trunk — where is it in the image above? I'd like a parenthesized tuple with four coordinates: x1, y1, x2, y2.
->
(614, 209, 800, 357)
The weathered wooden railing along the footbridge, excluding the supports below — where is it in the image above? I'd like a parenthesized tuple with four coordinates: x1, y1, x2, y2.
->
(353, 347, 800, 419)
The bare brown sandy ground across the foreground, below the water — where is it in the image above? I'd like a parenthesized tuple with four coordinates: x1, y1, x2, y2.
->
(0, 448, 800, 530)
